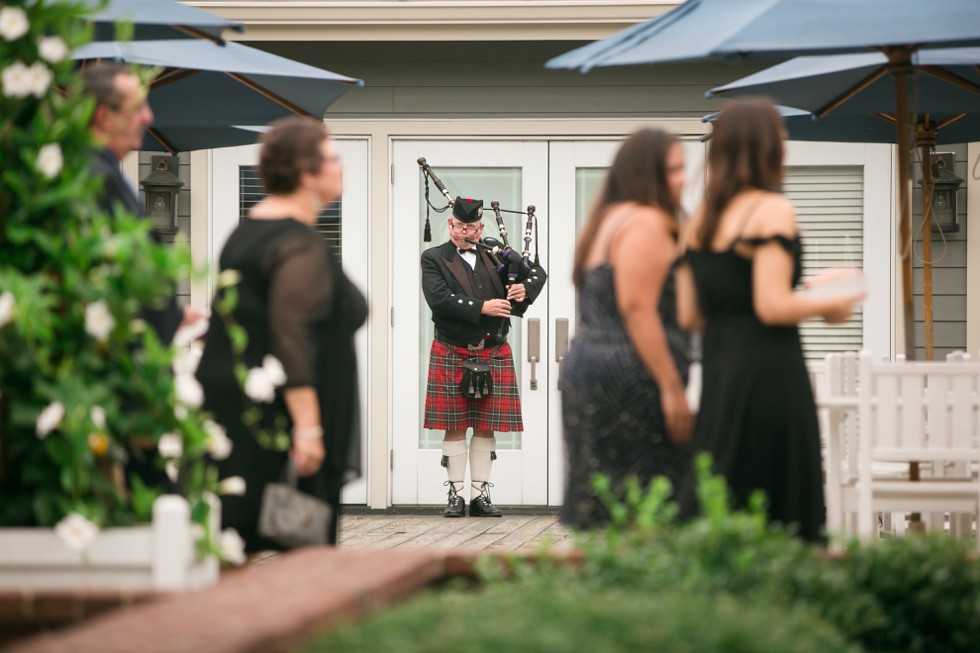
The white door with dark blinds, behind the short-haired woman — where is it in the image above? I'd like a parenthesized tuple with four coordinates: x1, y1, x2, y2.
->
(208, 138, 371, 504)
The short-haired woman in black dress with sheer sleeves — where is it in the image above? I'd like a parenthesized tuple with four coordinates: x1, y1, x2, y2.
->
(197, 118, 367, 551)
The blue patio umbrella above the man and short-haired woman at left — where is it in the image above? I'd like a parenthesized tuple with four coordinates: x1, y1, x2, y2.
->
(71, 39, 364, 152)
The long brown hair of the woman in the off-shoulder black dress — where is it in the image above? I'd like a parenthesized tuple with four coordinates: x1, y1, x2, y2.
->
(697, 98, 785, 248)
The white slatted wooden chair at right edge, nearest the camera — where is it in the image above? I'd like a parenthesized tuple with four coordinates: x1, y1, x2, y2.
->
(842, 354, 980, 546)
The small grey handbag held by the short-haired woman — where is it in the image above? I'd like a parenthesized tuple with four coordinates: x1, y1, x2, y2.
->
(259, 461, 333, 548)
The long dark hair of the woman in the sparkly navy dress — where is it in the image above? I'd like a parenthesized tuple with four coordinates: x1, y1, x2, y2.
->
(572, 129, 680, 288)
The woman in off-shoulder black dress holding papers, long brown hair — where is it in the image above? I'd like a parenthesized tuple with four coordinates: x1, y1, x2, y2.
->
(677, 100, 860, 541)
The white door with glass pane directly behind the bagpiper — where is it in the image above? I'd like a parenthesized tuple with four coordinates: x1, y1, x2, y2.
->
(390, 140, 552, 505)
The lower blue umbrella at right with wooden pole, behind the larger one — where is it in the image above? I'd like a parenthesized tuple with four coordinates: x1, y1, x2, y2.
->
(707, 48, 980, 359)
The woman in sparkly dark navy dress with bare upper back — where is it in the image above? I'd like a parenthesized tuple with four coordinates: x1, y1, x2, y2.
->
(560, 129, 692, 528)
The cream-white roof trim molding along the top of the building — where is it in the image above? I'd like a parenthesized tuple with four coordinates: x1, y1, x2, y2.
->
(185, 0, 681, 41)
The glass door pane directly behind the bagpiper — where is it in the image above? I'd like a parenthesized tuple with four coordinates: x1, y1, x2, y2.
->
(418, 166, 534, 449)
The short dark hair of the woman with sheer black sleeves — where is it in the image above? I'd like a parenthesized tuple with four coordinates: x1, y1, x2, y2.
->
(259, 116, 330, 195)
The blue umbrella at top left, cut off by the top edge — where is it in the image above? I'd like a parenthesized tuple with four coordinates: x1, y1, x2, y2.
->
(81, 0, 243, 43)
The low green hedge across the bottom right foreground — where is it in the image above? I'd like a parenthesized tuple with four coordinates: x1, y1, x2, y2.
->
(310, 458, 980, 653)
